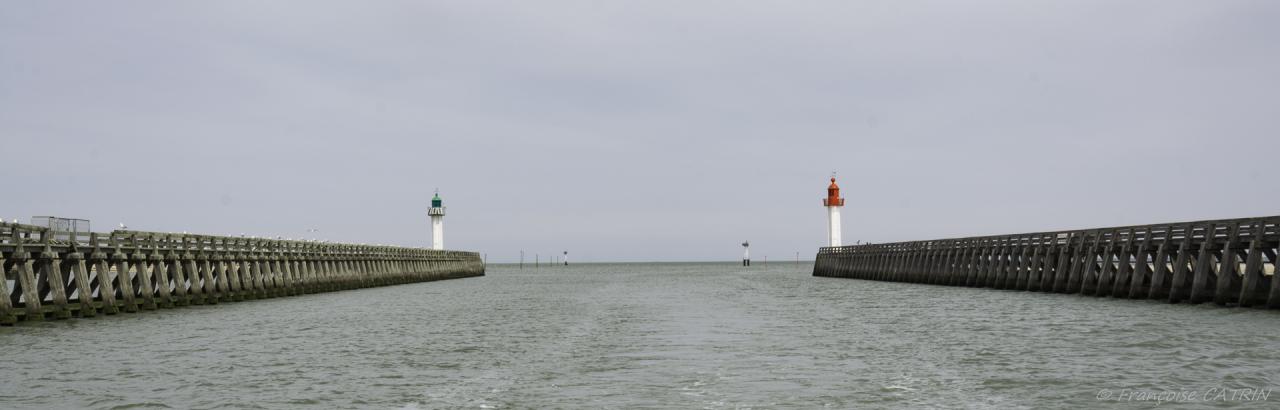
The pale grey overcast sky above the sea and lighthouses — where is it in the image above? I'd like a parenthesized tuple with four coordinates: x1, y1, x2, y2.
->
(0, 0, 1280, 261)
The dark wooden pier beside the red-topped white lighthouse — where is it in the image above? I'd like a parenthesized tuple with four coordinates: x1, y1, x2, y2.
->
(813, 217, 1280, 309)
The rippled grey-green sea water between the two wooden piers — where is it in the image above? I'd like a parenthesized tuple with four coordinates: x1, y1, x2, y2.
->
(0, 263, 1280, 409)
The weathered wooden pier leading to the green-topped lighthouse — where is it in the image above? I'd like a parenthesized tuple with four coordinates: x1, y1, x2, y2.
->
(0, 223, 484, 324)
